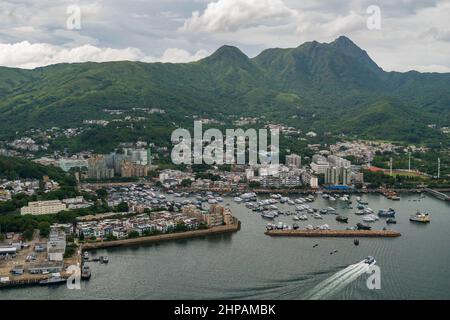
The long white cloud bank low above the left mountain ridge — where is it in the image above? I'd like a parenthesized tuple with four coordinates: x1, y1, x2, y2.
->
(0, 41, 208, 69)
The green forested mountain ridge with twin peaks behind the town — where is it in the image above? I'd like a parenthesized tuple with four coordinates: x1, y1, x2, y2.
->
(0, 37, 450, 142)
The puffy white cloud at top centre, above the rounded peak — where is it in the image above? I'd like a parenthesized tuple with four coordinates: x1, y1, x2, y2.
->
(180, 0, 296, 32)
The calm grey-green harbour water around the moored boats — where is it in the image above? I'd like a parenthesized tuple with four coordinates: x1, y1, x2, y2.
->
(0, 194, 450, 299)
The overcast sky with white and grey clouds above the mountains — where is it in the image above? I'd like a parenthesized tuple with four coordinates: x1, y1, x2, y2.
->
(0, 0, 450, 72)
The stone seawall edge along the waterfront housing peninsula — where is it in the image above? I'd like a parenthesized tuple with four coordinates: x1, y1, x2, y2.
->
(80, 218, 241, 252)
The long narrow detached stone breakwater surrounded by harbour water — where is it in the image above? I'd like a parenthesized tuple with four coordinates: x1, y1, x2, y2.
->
(265, 230, 401, 238)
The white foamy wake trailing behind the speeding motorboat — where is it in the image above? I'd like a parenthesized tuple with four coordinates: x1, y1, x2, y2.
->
(304, 260, 370, 300)
